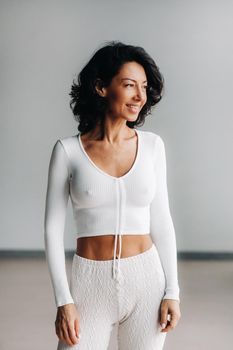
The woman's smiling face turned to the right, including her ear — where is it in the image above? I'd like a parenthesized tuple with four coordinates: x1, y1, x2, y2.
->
(96, 62, 147, 121)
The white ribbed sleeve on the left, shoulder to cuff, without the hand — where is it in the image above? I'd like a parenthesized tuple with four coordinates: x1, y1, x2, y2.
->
(44, 140, 74, 307)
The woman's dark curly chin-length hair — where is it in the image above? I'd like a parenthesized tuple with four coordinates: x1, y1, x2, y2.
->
(69, 41, 164, 134)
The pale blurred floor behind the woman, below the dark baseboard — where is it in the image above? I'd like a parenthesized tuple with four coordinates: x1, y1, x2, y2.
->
(0, 257, 233, 350)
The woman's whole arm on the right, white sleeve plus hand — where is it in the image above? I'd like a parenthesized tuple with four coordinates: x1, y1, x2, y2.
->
(150, 135, 180, 331)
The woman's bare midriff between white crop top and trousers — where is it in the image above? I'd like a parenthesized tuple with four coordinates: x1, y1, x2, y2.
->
(76, 233, 153, 260)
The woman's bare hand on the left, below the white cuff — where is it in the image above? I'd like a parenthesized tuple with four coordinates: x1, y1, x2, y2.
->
(55, 304, 81, 345)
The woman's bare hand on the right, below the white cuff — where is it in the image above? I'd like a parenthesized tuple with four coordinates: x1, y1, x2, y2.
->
(160, 299, 181, 332)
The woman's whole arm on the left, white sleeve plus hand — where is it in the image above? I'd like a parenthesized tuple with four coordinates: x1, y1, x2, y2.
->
(44, 140, 80, 345)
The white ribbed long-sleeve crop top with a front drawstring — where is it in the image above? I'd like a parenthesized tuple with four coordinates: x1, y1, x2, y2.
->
(44, 129, 180, 307)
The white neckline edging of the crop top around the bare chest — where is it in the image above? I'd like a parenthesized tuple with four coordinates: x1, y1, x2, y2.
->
(77, 128, 141, 180)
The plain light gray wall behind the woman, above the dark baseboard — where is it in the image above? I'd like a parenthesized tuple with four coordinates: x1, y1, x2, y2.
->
(0, 0, 233, 252)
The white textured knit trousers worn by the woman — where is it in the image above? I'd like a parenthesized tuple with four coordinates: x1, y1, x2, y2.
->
(57, 243, 167, 350)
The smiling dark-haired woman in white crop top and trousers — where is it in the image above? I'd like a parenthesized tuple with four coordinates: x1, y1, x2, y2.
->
(44, 41, 181, 350)
